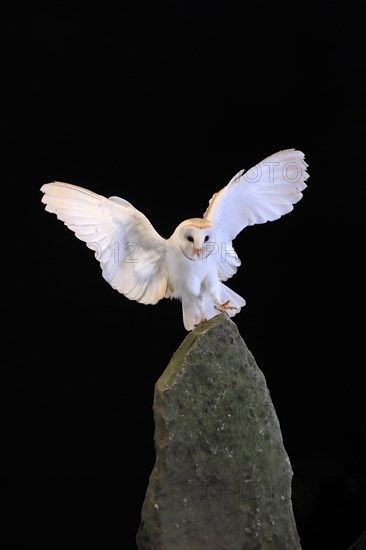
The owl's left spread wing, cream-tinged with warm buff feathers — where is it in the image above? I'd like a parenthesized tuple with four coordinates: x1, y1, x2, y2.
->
(41, 182, 168, 304)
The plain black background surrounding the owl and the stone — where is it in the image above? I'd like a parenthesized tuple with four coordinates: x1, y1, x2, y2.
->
(1, 4, 366, 550)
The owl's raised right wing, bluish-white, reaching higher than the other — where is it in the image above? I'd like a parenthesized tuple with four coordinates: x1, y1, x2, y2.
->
(203, 149, 308, 280)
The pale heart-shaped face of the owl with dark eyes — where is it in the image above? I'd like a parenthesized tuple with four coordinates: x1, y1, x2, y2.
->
(177, 223, 214, 261)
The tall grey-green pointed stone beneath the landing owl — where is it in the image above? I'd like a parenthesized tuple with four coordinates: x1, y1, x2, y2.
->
(137, 314, 301, 550)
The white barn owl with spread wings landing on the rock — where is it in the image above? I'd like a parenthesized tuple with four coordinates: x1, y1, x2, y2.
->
(41, 149, 308, 331)
